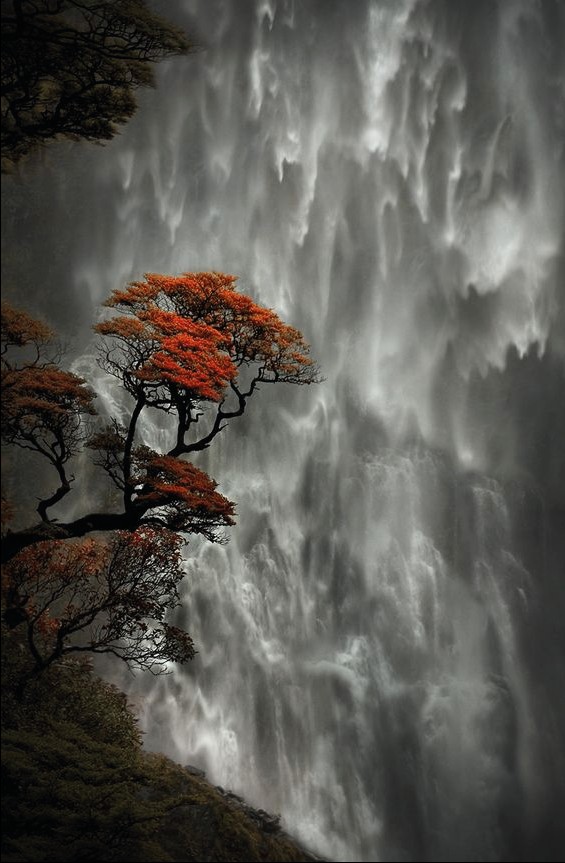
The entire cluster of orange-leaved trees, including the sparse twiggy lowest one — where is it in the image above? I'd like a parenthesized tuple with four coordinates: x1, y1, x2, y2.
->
(1, 272, 319, 673)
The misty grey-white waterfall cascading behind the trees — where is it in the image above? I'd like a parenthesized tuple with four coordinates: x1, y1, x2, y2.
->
(2, 0, 565, 861)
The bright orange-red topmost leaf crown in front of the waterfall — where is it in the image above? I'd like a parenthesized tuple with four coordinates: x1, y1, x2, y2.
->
(95, 273, 317, 402)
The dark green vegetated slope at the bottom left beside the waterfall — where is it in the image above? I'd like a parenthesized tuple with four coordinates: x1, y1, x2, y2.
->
(2, 629, 322, 863)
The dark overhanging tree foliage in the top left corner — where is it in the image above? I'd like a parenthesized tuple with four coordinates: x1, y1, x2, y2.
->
(1, 0, 190, 168)
